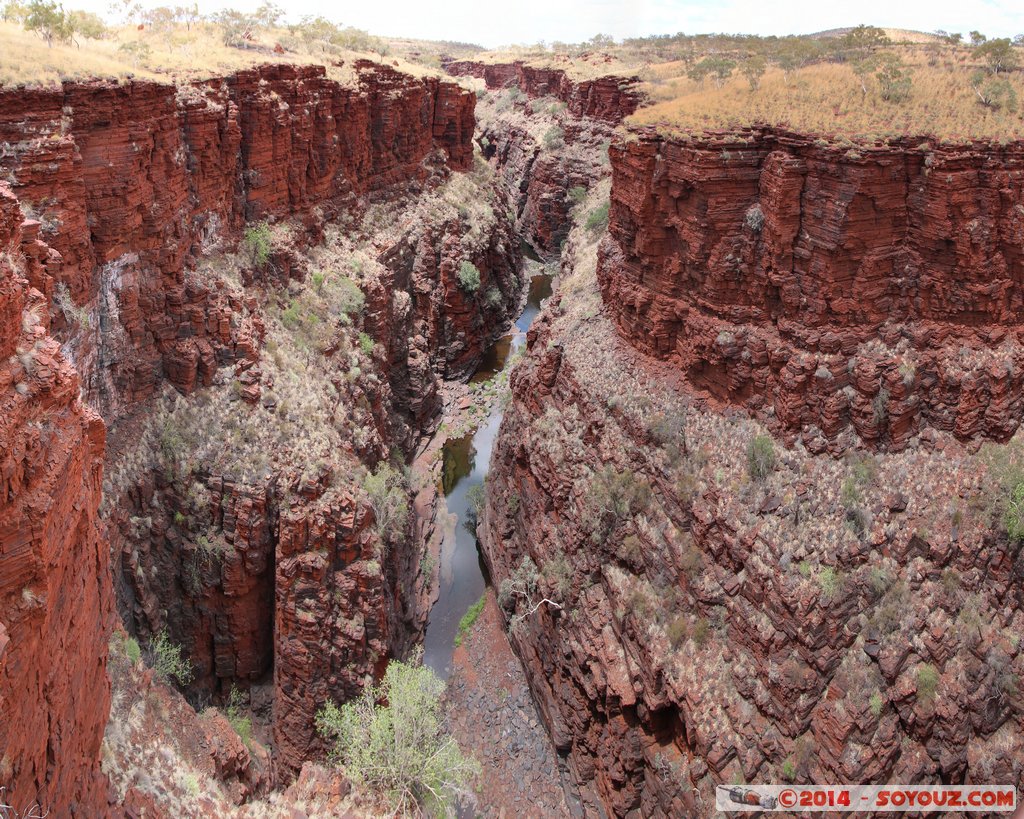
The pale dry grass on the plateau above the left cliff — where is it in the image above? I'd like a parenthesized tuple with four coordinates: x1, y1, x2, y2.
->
(0, 23, 437, 85)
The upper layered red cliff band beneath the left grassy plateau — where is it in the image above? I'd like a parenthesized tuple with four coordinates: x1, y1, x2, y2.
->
(0, 61, 475, 421)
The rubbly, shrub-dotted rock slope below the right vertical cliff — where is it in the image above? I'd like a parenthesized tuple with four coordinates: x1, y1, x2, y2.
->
(481, 177, 1024, 816)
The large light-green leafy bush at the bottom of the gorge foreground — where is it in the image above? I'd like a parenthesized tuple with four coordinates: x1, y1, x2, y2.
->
(316, 659, 480, 815)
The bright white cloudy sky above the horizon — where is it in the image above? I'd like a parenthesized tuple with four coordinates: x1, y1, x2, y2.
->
(81, 0, 1024, 47)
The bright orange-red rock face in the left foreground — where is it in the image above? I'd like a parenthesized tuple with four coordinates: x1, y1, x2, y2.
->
(0, 183, 114, 816)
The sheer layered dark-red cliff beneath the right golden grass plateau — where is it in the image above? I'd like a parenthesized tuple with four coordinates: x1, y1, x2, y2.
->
(598, 124, 1024, 452)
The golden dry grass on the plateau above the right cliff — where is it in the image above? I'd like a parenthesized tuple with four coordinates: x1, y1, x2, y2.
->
(629, 51, 1024, 141)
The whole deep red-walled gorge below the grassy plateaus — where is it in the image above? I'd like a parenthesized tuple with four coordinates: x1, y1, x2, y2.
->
(0, 30, 1024, 817)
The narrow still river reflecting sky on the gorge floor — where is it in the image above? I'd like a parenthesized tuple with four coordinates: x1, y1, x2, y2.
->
(423, 245, 551, 680)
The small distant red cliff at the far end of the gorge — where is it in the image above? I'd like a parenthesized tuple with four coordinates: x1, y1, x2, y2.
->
(444, 59, 643, 124)
